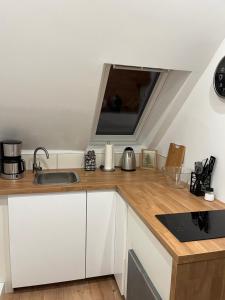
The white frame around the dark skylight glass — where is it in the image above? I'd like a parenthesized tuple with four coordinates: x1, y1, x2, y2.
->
(91, 64, 169, 145)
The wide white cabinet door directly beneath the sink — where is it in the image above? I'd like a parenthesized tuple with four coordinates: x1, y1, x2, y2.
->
(8, 192, 86, 288)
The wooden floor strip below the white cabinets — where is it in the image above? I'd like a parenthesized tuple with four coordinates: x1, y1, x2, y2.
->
(0, 277, 123, 300)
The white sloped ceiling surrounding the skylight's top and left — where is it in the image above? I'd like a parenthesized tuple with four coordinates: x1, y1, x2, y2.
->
(0, 0, 225, 150)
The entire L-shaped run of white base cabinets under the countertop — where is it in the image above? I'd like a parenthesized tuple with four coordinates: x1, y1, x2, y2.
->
(8, 190, 172, 300)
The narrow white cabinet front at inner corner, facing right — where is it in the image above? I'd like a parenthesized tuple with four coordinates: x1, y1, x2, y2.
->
(114, 193, 128, 295)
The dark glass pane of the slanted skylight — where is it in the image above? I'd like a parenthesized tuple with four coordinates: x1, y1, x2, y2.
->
(96, 66, 161, 136)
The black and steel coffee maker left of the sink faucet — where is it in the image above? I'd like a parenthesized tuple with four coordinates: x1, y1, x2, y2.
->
(1, 140, 25, 179)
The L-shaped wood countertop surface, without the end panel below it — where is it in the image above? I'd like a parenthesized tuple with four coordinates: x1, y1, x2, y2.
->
(0, 169, 225, 264)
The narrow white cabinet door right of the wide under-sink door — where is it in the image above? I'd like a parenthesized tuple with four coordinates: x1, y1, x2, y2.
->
(86, 191, 115, 278)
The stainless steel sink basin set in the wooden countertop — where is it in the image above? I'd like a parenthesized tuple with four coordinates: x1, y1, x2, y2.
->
(34, 172, 80, 184)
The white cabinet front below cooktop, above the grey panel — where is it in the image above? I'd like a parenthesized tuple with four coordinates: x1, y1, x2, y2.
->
(128, 207, 172, 300)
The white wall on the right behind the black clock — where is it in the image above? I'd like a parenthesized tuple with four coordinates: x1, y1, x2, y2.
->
(157, 40, 225, 201)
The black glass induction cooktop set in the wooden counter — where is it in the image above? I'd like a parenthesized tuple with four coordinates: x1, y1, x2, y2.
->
(156, 210, 225, 242)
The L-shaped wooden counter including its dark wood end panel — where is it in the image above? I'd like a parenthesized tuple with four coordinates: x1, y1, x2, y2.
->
(0, 169, 225, 300)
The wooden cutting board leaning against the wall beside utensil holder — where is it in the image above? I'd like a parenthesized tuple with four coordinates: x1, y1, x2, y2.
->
(166, 143, 185, 167)
